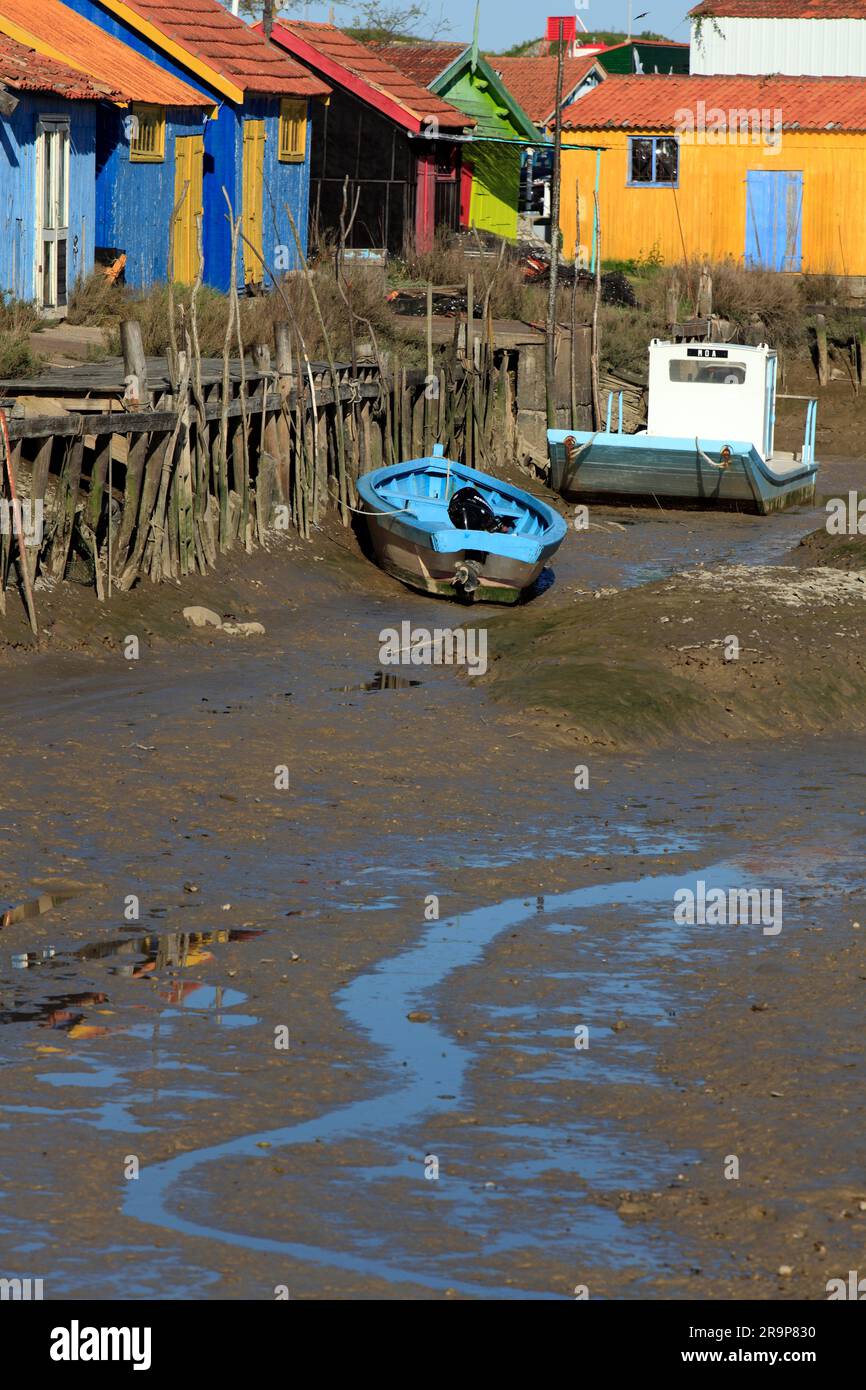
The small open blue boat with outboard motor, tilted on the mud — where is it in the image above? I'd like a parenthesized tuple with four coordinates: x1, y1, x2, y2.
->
(357, 445, 567, 603)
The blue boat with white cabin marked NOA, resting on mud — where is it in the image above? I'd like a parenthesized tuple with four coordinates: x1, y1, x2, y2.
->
(548, 341, 817, 514)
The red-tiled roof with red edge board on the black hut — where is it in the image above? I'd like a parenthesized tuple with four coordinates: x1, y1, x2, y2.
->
(269, 20, 475, 131)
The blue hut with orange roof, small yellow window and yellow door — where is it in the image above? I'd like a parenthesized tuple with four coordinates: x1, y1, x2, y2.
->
(0, 0, 213, 288)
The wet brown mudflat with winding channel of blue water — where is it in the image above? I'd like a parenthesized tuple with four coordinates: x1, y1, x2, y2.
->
(0, 461, 866, 1300)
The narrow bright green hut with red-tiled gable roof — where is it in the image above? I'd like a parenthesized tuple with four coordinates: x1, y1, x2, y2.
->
(377, 43, 538, 240)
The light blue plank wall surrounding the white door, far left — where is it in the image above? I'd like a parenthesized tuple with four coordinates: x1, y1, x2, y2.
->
(0, 92, 96, 299)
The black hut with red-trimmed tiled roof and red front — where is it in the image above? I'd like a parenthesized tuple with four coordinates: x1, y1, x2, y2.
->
(258, 19, 475, 253)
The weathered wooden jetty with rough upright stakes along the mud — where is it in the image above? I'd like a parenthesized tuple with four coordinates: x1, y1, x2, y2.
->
(0, 320, 536, 628)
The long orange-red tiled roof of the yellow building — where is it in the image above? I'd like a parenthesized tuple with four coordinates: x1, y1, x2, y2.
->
(563, 74, 866, 131)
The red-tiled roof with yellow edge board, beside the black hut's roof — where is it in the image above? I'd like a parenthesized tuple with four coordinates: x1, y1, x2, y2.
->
(105, 0, 329, 97)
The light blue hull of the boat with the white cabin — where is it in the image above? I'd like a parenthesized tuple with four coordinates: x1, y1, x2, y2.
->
(548, 430, 817, 514)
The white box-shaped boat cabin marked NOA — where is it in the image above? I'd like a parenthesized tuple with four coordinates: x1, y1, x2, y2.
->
(646, 338, 776, 461)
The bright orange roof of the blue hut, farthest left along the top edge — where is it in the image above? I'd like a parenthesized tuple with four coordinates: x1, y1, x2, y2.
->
(0, 0, 211, 106)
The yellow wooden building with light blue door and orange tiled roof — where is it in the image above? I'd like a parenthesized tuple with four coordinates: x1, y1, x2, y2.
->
(560, 75, 866, 275)
